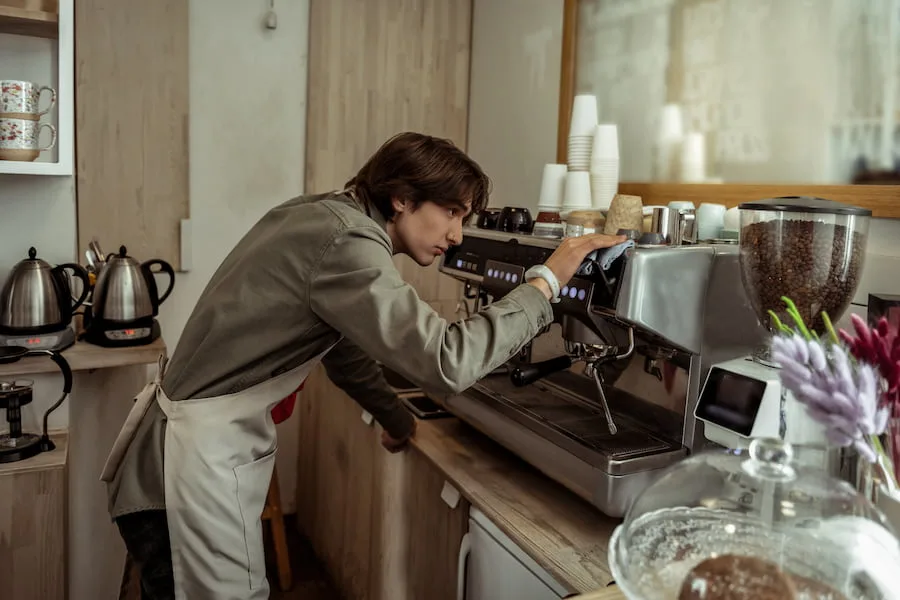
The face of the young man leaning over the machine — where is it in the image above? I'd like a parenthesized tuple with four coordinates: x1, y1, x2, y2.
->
(388, 198, 471, 267)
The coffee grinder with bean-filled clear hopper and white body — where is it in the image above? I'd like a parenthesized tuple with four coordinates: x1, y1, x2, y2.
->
(694, 196, 872, 448)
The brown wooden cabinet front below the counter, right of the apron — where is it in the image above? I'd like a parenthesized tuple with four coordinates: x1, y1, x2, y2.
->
(296, 367, 469, 600)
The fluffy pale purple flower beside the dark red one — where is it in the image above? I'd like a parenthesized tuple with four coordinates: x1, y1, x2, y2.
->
(771, 335, 889, 462)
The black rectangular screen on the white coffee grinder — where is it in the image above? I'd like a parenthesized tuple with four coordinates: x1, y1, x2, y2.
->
(696, 367, 766, 437)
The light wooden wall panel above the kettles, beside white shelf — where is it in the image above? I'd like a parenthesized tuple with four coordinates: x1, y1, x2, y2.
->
(75, 0, 190, 269)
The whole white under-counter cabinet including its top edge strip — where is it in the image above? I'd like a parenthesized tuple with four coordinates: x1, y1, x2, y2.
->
(457, 508, 568, 600)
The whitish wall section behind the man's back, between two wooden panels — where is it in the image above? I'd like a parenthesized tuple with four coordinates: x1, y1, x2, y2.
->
(160, 0, 309, 511)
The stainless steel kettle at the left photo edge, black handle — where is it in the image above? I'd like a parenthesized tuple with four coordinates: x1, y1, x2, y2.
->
(0, 247, 91, 335)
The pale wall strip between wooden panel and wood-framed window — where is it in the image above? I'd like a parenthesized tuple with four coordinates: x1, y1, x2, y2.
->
(468, 0, 563, 212)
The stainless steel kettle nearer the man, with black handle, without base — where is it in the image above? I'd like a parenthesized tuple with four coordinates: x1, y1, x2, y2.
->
(91, 246, 175, 323)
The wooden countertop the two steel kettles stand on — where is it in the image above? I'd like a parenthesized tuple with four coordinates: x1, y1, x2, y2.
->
(0, 338, 166, 377)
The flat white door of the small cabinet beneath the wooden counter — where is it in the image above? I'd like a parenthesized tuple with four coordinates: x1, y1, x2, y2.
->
(465, 520, 563, 600)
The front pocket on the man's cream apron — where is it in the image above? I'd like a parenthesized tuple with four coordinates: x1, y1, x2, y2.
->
(234, 450, 275, 590)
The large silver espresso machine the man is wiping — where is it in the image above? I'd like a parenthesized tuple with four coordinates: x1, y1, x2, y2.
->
(440, 227, 764, 517)
